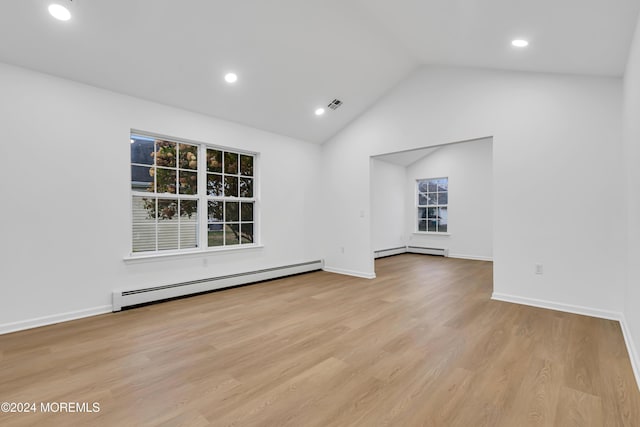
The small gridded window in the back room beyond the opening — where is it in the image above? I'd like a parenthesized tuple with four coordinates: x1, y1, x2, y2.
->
(416, 178, 449, 233)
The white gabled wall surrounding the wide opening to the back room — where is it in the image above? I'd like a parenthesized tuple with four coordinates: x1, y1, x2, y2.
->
(322, 67, 626, 315)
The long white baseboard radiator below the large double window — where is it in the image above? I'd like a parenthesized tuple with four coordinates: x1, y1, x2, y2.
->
(113, 260, 324, 312)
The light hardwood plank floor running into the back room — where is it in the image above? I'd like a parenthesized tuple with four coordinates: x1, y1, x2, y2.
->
(0, 255, 640, 427)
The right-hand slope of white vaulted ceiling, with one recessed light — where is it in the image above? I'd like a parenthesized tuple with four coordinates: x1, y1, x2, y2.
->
(355, 0, 640, 76)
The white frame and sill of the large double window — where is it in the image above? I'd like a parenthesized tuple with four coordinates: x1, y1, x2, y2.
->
(124, 129, 263, 260)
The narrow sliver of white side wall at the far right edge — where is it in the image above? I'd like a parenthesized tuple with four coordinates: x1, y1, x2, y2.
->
(624, 12, 640, 382)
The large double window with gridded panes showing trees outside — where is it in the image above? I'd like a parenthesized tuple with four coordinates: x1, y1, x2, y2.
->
(131, 133, 256, 252)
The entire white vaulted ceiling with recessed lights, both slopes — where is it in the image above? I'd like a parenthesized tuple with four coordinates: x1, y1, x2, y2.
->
(0, 0, 640, 142)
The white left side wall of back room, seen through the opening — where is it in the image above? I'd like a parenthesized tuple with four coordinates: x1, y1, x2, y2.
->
(371, 159, 407, 251)
